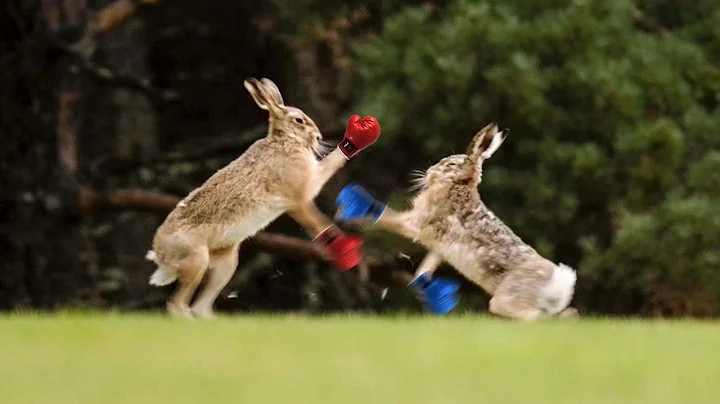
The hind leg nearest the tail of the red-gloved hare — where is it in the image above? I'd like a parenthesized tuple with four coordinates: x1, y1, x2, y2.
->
(167, 247, 209, 318)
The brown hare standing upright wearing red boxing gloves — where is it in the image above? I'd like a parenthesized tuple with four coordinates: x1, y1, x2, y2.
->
(147, 79, 380, 318)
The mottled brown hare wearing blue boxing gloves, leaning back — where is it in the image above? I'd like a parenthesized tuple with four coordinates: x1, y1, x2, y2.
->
(336, 124, 577, 320)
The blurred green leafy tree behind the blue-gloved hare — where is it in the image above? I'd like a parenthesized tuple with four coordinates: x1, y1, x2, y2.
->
(354, 0, 720, 315)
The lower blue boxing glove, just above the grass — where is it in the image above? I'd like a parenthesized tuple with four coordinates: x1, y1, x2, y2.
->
(408, 272, 460, 315)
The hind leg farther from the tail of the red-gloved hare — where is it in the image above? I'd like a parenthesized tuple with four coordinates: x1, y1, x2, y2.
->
(192, 244, 240, 319)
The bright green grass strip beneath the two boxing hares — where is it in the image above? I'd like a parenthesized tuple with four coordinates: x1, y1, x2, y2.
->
(0, 314, 720, 404)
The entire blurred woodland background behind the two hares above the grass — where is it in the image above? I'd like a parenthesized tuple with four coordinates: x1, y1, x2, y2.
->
(0, 0, 720, 317)
